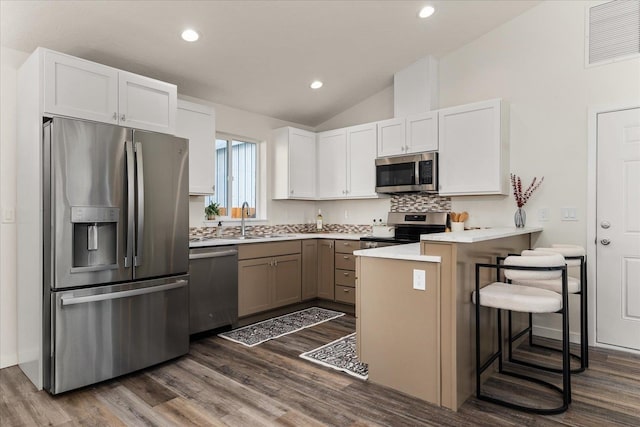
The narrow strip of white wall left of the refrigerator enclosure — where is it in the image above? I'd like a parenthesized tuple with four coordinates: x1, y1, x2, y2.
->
(0, 48, 28, 368)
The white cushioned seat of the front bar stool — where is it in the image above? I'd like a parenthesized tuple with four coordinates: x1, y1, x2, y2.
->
(473, 282, 562, 313)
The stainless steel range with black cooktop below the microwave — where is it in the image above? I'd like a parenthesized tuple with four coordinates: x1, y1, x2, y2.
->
(360, 212, 448, 249)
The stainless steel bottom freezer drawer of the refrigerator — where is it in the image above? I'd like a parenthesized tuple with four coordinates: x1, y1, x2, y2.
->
(49, 275, 189, 394)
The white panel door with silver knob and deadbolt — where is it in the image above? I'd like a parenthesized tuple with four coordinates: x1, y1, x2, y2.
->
(596, 108, 640, 350)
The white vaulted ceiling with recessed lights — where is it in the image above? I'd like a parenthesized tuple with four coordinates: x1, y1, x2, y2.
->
(0, 0, 539, 127)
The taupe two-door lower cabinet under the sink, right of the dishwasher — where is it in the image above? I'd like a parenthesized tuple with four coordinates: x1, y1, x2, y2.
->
(238, 240, 302, 317)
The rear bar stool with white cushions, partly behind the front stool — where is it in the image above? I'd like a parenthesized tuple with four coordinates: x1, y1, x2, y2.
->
(508, 244, 589, 374)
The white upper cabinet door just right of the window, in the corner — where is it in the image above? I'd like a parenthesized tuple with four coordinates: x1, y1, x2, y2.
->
(288, 128, 316, 199)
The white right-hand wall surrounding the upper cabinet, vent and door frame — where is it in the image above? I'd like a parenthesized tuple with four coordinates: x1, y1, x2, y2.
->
(440, 1, 640, 246)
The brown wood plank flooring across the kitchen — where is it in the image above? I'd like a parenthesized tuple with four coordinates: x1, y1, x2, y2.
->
(0, 310, 640, 427)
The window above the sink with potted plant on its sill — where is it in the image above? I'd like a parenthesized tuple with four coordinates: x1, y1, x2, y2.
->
(205, 135, 259, 219)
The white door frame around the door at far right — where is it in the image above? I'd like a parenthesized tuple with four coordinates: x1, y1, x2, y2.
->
(585, 102, 640, 354)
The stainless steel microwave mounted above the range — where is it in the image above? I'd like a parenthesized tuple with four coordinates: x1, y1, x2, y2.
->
(376, 151, 438, 193)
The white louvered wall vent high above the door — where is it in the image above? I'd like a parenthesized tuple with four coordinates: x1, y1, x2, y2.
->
(586, 0, 640, 65)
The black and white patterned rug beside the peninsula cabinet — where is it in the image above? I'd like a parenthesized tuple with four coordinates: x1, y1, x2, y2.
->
(300, 332, 369, 380)
